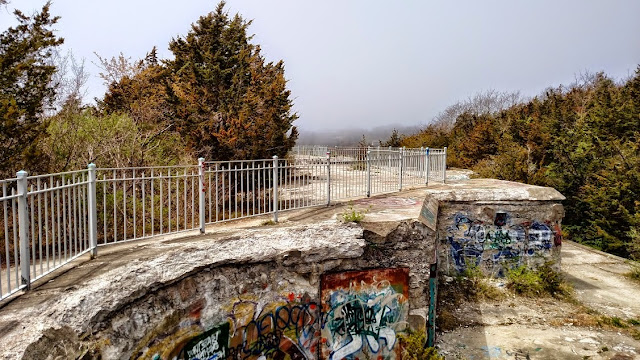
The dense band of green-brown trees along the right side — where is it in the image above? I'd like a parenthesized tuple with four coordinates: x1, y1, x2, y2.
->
(401, 66, 640, 260)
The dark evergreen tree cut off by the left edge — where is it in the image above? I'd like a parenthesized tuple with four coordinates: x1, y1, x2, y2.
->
(0, 3, 63, 177)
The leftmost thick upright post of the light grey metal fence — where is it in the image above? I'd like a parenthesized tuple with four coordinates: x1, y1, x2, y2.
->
(16, 170, 31, 290)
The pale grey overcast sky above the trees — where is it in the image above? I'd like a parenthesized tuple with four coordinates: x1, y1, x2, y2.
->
(0, 0, 640, 131)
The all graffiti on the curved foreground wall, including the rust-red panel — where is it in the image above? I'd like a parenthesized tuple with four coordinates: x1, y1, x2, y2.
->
(139, 268, 409, 360)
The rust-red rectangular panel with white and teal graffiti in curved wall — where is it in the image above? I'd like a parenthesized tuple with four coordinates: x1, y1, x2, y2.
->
(321, 268, 409, 360)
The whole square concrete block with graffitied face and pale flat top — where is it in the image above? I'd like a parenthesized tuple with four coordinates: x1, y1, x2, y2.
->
(420, 179, 564, 277)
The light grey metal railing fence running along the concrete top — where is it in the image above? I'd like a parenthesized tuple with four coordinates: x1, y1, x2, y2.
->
(0, 146, 446, 300)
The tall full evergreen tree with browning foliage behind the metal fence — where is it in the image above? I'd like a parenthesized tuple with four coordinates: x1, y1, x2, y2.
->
(167, 2, 298, 160)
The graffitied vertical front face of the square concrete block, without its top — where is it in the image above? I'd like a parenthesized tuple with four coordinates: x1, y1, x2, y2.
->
(438, 201, 563, 277)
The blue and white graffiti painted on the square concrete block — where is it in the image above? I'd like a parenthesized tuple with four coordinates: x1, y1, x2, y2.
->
(447, 212, 561, 276)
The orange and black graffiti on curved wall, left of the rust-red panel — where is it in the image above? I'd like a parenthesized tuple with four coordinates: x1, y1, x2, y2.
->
(138, 293, 321, 360)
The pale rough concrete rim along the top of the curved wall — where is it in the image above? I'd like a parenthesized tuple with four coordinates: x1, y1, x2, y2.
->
(0, 222, 365, 359)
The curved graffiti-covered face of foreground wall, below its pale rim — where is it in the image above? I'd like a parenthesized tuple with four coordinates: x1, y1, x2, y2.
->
(16, 221, 435, 359)
